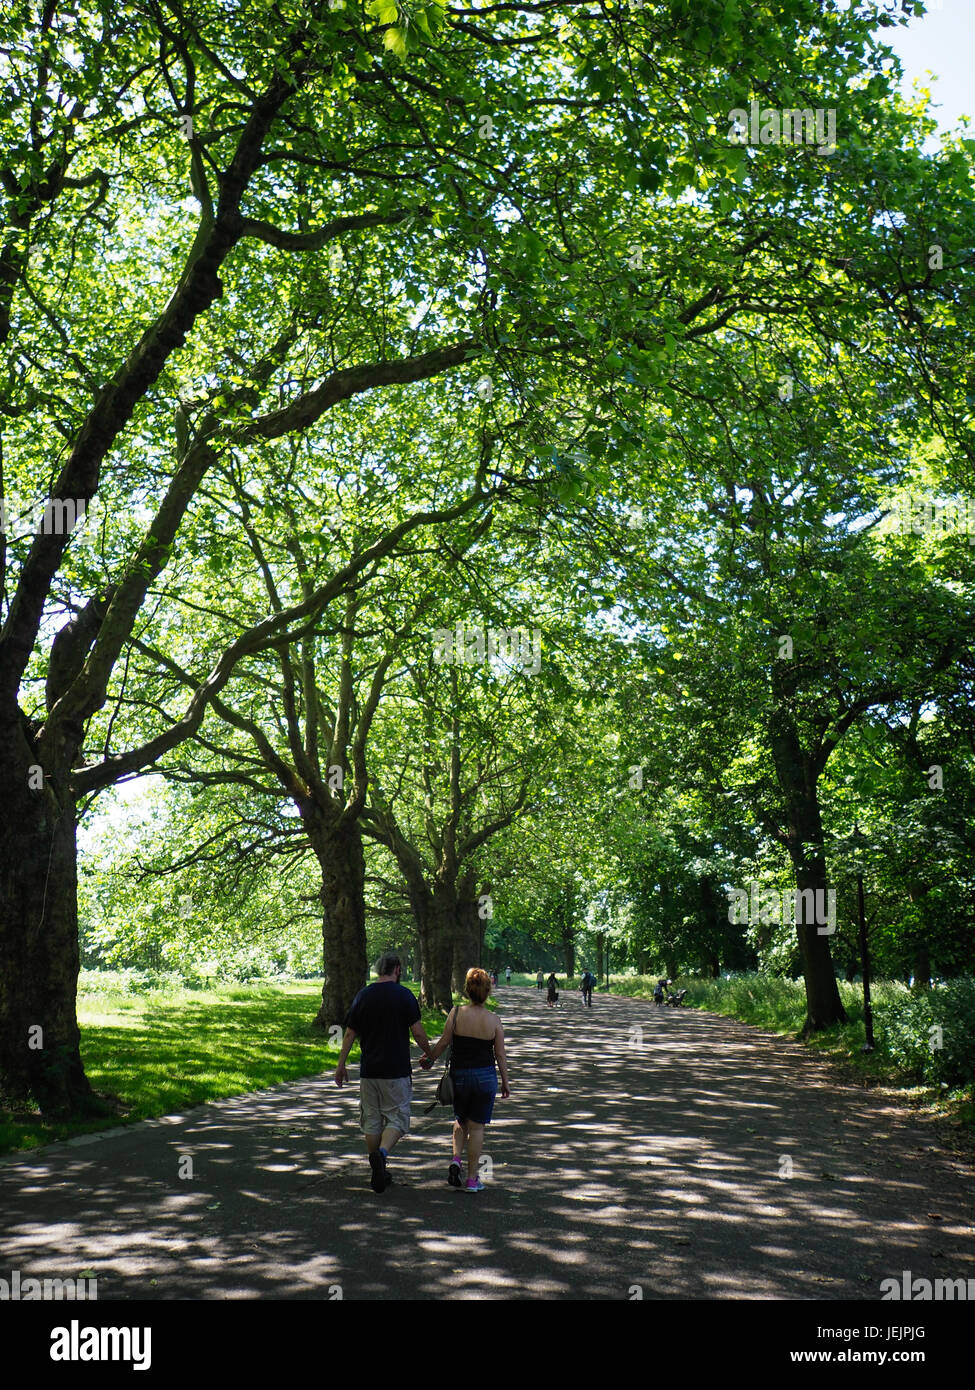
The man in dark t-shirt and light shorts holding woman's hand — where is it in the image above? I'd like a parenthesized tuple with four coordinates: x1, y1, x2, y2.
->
(335, 951, 430, 1193)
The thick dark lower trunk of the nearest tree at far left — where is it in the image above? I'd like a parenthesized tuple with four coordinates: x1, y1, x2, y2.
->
(0, 706, 97, 1118)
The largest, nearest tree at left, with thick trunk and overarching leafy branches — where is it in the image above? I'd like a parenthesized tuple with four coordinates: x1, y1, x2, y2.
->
(0, 0, 945, 1113)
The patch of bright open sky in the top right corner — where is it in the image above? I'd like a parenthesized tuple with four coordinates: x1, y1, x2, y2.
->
(875, 0, 975, 131)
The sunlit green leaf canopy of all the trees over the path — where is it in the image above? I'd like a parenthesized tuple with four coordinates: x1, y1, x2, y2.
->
(0, 0, 975, 1106)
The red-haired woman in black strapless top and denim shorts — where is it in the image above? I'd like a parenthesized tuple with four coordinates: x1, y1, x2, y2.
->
(420, 969, 510, 1193)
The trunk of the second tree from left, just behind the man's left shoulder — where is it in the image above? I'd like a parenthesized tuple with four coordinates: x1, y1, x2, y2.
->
(305, 810, 369, 1029)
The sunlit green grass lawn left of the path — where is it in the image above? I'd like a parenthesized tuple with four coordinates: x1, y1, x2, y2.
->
(0, 972, 458, 1154)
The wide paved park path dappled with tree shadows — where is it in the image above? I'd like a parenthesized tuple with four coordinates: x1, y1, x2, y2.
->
(0, 987, 975, 1301)
